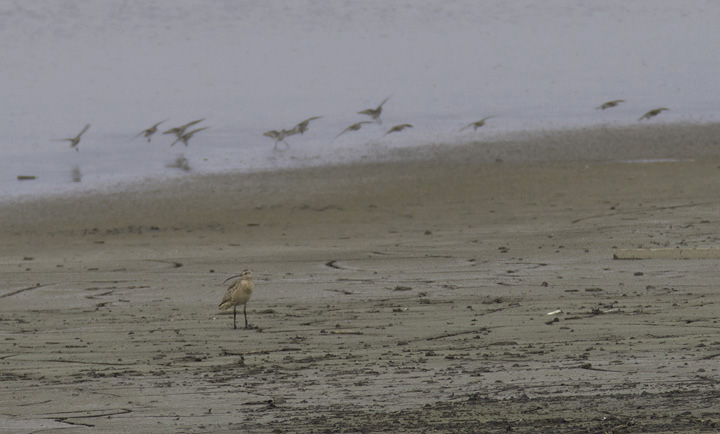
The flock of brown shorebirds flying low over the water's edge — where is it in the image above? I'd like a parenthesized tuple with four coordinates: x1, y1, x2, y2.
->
(54, 97, 670, 151)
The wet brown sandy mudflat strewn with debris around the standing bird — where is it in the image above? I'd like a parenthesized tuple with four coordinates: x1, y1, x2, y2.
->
(0, 125, 720, 433)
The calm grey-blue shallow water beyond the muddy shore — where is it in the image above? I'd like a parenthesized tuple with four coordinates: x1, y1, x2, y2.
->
(0, 0, 720, 199)
